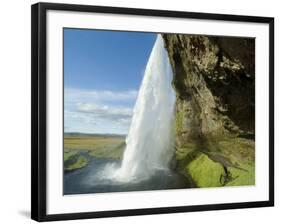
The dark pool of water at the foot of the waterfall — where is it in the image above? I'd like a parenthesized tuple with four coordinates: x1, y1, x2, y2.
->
(63, 155, 192, 195)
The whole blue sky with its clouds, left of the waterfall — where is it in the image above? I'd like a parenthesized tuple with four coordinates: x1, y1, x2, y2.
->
(64, 29, 156, 134)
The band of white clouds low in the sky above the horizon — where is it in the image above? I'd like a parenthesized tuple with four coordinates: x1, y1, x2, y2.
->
(64, 88, 137, 133)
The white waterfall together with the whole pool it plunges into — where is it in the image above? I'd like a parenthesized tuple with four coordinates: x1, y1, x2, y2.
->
(64, 35, 190, 194)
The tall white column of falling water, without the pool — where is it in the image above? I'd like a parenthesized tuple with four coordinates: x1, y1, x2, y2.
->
(114, 35, 175, 181)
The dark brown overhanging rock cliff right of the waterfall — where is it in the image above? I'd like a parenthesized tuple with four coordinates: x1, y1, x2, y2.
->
(163, 34, 255, 144)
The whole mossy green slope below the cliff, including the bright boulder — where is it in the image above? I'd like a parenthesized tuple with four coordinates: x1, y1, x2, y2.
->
(176, 136, 255, 187)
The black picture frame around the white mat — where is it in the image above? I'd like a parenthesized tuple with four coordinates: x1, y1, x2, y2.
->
(31, 3, 274, 221)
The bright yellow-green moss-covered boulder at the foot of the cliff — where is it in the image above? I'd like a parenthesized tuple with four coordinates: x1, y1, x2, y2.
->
(186, 153, 224, 187)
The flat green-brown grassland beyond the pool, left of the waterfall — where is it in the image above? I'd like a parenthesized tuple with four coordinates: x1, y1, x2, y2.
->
(64, 134, 126, 171)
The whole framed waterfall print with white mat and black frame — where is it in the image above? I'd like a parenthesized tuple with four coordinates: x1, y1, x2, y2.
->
(31, 3, 274, 221)
